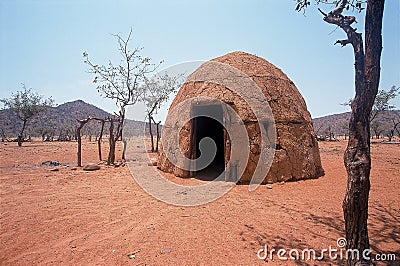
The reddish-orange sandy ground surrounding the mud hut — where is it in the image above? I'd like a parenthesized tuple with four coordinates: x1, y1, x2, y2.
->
(0, 138, 400, 265)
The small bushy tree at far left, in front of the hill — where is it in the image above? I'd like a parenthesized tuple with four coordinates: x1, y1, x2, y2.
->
(0, 84, 54, 147)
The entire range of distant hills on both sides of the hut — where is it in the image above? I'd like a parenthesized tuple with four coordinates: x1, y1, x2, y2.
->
(0, 100, 400, 138)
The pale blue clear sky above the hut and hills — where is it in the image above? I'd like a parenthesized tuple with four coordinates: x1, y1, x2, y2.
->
(0, 0, 400, 120)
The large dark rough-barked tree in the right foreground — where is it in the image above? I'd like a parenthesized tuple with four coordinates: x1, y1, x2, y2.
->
(296, 0, 385, 265)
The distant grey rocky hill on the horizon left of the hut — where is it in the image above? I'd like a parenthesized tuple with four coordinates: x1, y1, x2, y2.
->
(0, 100, 145, 138)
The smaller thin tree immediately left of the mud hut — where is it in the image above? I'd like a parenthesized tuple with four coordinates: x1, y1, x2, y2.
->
(142, 73, 183, 152)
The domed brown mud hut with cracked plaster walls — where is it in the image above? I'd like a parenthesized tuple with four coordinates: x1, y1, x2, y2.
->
(158, 52, 324, 183)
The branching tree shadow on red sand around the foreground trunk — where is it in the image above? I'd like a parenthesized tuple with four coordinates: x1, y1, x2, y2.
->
(240, 197, 400, 265)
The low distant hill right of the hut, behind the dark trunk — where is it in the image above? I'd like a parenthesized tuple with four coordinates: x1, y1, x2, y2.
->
(313, 110, 400, 136)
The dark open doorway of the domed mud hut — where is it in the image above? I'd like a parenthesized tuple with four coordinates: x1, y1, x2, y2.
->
(191, 105, 225, 181)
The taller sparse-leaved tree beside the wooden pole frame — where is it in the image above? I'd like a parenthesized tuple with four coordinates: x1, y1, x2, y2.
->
(83, 29, 162, 163)
